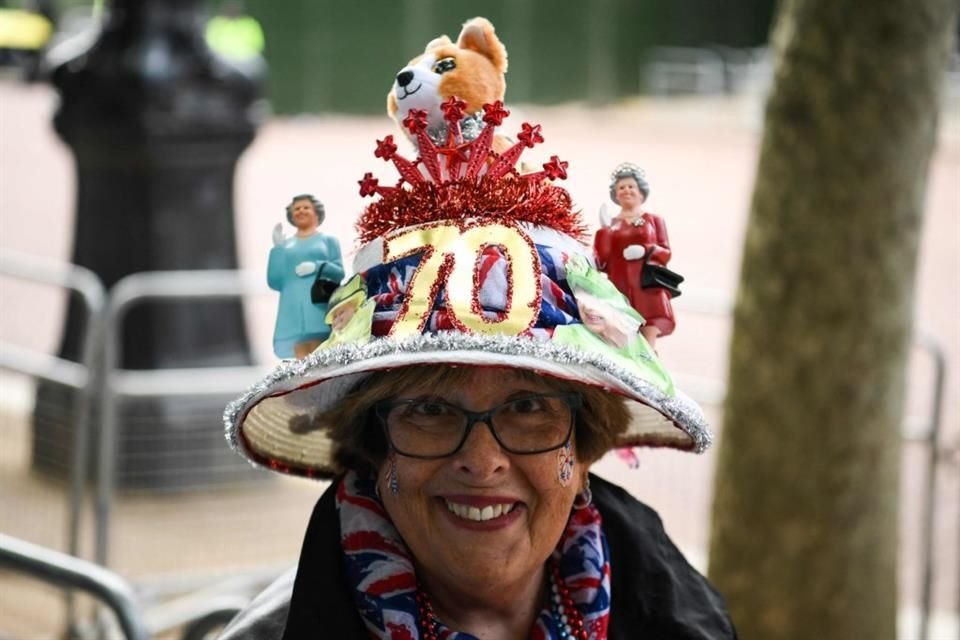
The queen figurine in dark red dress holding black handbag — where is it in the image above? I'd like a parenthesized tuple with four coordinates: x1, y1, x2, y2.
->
(594, 163, 683, 347)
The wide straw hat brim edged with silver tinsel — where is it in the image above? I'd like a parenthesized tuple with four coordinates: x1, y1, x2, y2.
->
(224, 332, 712, 478)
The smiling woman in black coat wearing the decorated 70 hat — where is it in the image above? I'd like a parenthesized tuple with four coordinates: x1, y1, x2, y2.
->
(223, 107, 735, 640)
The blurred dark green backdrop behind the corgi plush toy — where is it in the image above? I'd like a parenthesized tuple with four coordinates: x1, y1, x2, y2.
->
(242, 0, 773, 113)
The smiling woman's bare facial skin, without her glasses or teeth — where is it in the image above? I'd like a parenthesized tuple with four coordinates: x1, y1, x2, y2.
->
(378, 368, 586, 587)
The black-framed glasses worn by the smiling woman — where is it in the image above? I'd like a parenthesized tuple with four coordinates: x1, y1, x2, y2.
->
(374, 393, 583, 458)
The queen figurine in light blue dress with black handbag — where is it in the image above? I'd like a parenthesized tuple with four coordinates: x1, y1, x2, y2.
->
(267, 194, 344, 358)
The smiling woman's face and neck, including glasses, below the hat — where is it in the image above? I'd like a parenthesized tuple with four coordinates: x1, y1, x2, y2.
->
(331, 366, 600, 637)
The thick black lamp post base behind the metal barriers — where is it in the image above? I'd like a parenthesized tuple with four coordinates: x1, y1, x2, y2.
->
(33, 0, 262, 486)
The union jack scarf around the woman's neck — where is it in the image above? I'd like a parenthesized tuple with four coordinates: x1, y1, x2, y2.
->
(337, 472, 610, 640)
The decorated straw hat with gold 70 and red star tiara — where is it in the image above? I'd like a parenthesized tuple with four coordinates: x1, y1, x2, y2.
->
(224, 98, 711, 477)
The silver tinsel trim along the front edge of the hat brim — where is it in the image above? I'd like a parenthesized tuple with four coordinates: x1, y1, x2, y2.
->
(223, 331, 713, 455)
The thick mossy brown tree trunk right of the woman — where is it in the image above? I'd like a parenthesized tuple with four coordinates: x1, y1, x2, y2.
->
(710, 0, 957, 640)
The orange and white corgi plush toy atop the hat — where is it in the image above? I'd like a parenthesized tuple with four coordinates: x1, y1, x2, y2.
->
(387, 18, 507, 148)
